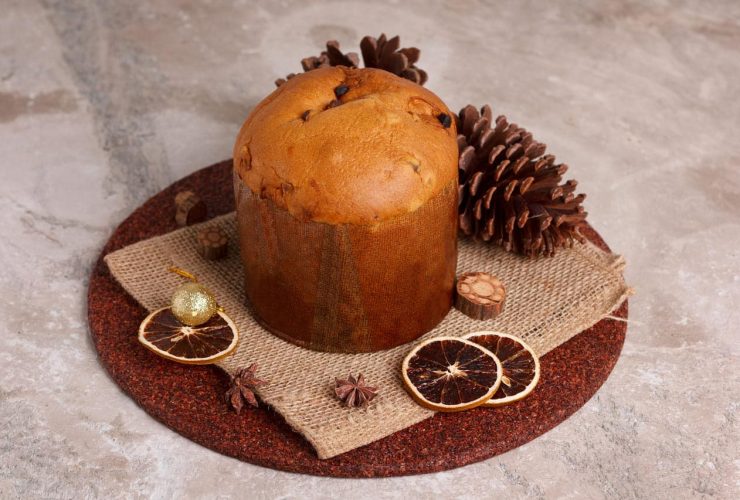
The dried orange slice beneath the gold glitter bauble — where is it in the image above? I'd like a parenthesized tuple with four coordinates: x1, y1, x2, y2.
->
(139, 307, 239, 365)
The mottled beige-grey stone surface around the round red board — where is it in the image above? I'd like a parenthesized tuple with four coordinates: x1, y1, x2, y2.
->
(0, 0, 740, 498)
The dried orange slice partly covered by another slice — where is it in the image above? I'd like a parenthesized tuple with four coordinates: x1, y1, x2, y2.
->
(465, 332, 540, 406)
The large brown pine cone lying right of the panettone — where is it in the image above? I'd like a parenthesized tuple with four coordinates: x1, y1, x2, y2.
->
(456, 105, 587, 257)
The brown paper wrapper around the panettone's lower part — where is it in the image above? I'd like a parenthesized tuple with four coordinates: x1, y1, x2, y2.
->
(234, 172, 457, 353)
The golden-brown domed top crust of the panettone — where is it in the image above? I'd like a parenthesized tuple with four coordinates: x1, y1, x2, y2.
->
(234, 67, 458, 224)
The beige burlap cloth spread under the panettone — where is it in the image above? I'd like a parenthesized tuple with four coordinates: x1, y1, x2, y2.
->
(105, 212, 629, 458)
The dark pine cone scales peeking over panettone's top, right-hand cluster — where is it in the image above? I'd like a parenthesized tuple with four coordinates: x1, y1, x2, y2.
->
(360, 33, 427, 85)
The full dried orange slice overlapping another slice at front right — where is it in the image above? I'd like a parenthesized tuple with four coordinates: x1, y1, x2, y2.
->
(402, 337, 502, 411)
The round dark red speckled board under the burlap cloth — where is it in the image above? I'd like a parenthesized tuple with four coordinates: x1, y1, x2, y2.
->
(88, 160, 627, 477)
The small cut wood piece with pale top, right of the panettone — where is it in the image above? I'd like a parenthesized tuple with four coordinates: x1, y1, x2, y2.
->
(455, 272, 506, 320)
